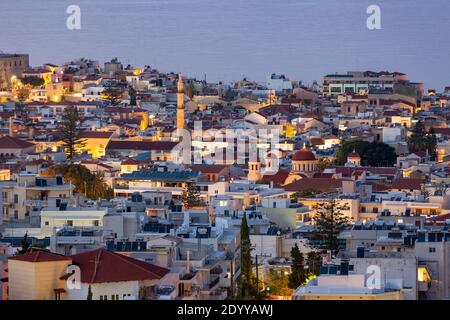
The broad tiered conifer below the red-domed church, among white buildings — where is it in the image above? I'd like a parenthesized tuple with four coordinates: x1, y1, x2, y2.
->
(313, 199, 350, 253)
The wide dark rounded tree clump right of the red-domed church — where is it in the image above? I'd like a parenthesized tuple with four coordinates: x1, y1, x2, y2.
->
(335, 140, 397, 167)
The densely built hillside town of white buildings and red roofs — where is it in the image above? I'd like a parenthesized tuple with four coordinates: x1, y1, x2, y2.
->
(0, 53, 450, 300)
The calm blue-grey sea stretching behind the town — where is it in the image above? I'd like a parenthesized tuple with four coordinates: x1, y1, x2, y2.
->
(0, 0, 450, 90)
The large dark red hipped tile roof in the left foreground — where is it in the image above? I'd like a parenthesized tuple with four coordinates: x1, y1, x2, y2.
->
(70, 248, 169, 283)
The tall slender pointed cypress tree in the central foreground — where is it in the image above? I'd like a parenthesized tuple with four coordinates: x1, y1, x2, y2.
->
(238, 213, 258, 300)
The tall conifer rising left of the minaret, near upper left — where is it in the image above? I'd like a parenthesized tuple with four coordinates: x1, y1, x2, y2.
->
(61, 106, 84, 160)
